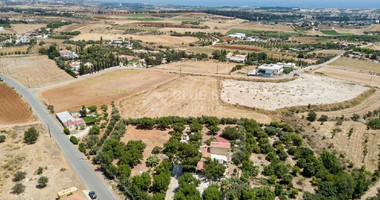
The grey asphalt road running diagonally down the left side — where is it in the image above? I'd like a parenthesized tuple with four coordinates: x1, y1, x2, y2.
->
(0, 74, 116, 200)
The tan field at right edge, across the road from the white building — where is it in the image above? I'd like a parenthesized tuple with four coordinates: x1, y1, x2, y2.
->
(329, 57, 380, 74)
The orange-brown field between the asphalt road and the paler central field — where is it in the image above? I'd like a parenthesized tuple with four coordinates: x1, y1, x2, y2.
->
(38, 69, 178, 112)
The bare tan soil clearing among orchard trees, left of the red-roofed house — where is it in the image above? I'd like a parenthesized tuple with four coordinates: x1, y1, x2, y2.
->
(121, 126, 170, 176)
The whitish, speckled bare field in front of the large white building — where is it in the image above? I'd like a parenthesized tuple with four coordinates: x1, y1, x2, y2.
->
(221, 74, 369, 110)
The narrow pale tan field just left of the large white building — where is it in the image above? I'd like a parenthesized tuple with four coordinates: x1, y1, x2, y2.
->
(156, 61, 236, 74)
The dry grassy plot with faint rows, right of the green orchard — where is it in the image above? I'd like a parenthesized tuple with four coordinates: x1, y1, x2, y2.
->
(311, 121, 380, 172)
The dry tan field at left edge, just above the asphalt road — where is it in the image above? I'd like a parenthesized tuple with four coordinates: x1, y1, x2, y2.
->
(0, 56, 74, 88)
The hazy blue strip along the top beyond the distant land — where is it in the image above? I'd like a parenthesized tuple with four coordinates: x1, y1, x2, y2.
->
(103, 0, 380, 8)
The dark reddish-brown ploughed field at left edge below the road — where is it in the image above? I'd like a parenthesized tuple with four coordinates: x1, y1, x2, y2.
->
(0, 83, 32, 126)
